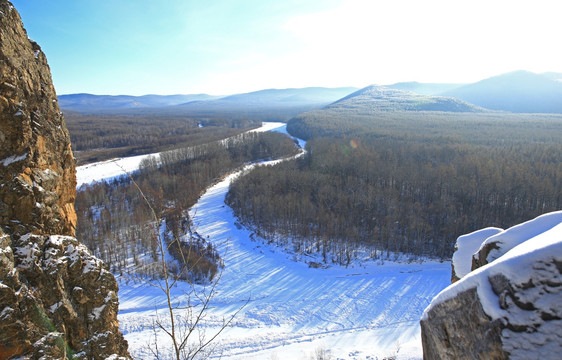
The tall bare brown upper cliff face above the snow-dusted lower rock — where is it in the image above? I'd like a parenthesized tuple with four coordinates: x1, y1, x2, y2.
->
(0, 1, 76, 239)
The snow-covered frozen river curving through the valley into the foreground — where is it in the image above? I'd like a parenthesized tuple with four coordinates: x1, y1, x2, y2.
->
(75, 124, 450, 360)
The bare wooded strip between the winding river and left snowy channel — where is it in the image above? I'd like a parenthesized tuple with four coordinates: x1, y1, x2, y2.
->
(76, 133, 297, 280)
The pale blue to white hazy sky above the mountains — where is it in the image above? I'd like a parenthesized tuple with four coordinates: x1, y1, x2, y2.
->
(12, 0, 562, 95)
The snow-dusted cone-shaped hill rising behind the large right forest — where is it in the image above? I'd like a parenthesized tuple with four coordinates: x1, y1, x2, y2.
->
(326, 85, 486, 113)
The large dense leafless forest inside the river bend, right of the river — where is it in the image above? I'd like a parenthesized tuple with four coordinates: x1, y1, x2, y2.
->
(227, 110, 562, 264)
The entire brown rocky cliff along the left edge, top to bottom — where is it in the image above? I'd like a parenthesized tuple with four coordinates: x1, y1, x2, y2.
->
(0, 0, 128, 359)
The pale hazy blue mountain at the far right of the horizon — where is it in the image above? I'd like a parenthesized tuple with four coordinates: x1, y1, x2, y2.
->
(443, 71, 562, 113)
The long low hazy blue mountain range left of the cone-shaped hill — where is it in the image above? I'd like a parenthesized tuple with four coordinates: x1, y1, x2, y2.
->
(59, 87, 357, 121)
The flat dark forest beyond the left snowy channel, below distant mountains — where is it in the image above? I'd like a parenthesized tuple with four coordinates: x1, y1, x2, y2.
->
(65, 111, 261, 165)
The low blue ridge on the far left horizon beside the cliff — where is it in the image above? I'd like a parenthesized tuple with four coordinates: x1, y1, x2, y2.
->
(58, 94, 217, 112)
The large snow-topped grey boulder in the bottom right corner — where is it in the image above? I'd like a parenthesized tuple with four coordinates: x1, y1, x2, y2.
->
(421, 212, 562, 359)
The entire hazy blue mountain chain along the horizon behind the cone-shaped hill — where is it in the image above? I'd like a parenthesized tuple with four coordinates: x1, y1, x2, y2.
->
(59, 70, 562, 114)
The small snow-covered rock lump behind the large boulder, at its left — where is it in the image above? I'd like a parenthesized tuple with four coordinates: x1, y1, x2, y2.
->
(451, 227, 503, 282)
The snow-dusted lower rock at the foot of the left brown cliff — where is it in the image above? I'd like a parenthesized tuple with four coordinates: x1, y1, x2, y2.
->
(6, 234, 127, 358)
